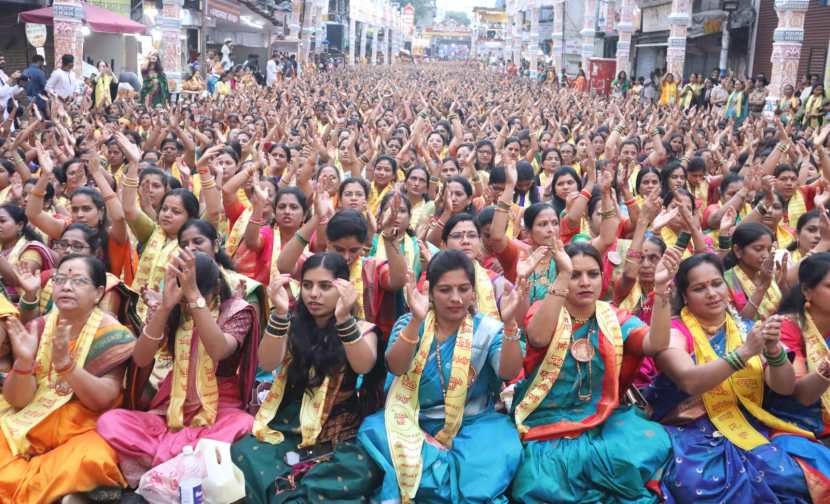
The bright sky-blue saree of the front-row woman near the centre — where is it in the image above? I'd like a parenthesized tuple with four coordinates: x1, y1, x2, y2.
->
(357, 314, 522, 503)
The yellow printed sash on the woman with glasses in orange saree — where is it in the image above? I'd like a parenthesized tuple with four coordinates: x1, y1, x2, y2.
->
(0, 308, 104, 456)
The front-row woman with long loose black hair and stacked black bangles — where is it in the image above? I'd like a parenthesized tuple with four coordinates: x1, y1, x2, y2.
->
(231, 252, 386, 504)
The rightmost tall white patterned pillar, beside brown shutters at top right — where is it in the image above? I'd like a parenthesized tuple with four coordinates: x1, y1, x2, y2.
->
(766, 0, 809, 113)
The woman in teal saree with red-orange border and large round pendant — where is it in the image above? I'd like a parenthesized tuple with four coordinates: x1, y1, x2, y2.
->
(512, 240, 682, 503)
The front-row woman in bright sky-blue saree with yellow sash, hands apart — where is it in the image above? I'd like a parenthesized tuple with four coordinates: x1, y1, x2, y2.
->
(358, 250, 527, 502)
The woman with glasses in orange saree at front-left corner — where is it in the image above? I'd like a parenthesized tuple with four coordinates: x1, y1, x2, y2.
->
(0, 255, 135, 503)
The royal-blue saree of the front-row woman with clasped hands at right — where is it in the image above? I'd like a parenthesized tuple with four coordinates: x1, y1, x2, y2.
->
(646, 320, 830, 504)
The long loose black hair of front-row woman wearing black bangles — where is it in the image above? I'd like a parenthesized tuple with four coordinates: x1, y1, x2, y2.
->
(287, 252, 385, 413)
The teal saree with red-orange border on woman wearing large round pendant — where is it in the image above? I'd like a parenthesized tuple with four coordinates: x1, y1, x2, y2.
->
(511, 312, 671, 504)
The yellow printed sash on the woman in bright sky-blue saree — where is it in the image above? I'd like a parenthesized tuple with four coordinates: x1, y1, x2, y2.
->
(384, 310, 473, 503)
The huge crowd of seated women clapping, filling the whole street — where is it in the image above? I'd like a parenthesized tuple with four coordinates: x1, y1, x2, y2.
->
(0, 64, 830, 503)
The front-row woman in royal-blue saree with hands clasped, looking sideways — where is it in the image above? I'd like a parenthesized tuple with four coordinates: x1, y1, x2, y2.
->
(647, 254, 830, 504)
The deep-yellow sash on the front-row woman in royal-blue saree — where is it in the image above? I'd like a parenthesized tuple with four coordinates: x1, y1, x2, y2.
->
(680, 308, 815, 451)
